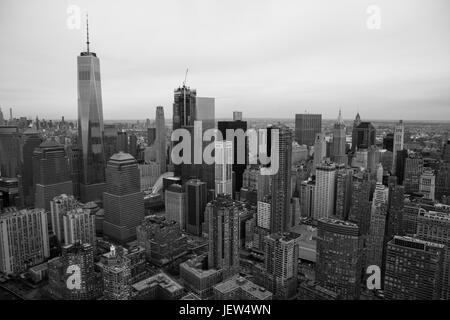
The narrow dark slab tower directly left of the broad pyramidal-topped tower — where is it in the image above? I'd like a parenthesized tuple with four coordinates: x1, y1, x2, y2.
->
(22, 128, 42, 207)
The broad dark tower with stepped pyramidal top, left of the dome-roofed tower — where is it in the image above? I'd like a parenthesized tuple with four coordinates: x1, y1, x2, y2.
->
(33, 140, 73, 211)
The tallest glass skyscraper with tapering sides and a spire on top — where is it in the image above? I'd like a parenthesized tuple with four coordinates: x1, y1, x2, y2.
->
(77, 19, 106, 202)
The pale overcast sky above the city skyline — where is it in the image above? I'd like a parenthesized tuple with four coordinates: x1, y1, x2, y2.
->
(0, 0, 450, 120)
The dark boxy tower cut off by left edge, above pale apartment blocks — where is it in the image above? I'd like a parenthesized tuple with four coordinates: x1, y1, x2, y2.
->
(0, 126, 21, 178)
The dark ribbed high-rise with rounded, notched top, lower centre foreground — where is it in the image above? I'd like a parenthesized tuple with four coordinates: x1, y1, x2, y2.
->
(205, 194, 241, 278)
